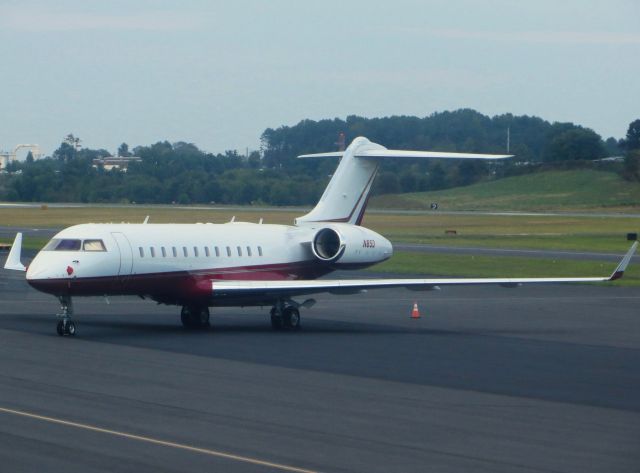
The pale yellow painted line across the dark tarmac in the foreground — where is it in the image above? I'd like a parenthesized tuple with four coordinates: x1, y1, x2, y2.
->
(0, 407, 318, 473)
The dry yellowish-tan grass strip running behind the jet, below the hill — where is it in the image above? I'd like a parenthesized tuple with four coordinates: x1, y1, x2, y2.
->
(0, 206, 640, 252)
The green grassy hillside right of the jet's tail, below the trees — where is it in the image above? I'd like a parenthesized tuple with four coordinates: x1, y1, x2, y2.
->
(371, 170, 640, 211)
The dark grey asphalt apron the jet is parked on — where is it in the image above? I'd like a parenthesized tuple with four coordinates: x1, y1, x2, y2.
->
(0, 270, 640, 472)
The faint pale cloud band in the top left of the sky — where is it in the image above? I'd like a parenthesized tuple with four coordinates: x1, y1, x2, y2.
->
(0, 7, 202, 32)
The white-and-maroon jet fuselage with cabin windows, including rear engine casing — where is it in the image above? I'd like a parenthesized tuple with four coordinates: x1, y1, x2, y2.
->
(27, 222, 392, 305)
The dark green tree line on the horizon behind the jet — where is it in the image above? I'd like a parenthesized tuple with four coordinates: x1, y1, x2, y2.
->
(0, 110, 640, 205)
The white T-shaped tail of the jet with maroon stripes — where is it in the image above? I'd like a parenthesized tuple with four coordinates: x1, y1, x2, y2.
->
(295, 137, 510, 225)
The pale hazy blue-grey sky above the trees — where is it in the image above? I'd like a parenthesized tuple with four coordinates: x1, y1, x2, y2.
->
(0, 0, 640, 159)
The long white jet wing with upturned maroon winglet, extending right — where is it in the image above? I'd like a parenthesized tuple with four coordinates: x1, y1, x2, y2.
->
(212, 241, 638, 297)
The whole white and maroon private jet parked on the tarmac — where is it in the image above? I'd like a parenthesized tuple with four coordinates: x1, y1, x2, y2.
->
(4, 137, 638, 336)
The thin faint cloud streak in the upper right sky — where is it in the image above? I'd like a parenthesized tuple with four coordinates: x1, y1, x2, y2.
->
(405, 28, 640, 45)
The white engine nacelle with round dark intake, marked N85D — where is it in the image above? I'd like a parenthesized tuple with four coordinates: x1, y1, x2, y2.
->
(311, 223, 393, 267)
